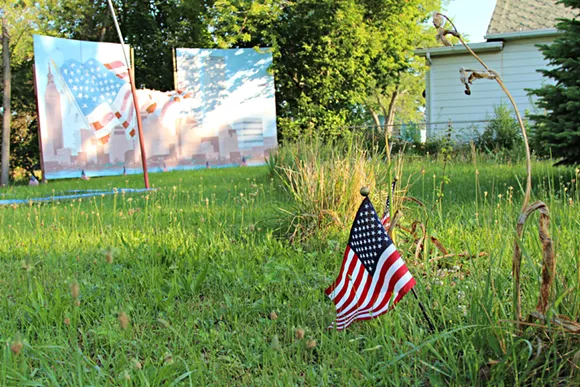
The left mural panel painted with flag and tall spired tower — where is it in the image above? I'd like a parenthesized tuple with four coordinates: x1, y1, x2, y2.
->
(34, 35, 141, 179)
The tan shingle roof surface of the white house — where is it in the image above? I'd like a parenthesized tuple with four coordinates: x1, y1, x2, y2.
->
(487, 0, 577, 35)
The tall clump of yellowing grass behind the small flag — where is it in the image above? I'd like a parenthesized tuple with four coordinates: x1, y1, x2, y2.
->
(269, 139, 390, 240)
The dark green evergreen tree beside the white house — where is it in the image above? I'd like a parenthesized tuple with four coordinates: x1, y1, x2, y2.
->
(531, 0, 580, 164)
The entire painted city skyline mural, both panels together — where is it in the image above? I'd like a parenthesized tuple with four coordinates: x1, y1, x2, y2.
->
(34, 36, 276, 179)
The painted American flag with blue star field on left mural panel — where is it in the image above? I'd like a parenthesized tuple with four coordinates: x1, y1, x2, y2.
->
(60, 59, 135, 144)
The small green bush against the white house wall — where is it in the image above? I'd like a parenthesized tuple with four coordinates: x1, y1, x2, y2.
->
(476, 104, 523, 153)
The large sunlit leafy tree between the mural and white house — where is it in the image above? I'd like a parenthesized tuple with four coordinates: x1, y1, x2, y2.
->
(212, 0, 440, 141)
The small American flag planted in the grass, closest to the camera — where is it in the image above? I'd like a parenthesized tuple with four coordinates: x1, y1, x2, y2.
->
(325, 198, 415, 330)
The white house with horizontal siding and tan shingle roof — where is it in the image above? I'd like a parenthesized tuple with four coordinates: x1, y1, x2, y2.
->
(416, 0, 576, 138)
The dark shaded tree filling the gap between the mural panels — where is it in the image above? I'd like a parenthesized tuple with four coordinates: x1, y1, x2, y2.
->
(53, 0, 215, 90)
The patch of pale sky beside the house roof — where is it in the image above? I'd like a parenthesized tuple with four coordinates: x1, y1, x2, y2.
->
(444, 0, 496, 43)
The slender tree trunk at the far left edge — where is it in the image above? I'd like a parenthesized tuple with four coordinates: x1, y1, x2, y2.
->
(0, 17, 11, 186)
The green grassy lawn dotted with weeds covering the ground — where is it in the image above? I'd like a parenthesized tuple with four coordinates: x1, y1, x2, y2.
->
(0, 159, 580, 386)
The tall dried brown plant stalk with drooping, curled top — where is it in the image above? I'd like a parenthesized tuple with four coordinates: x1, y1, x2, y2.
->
(433, 12, 556, 328)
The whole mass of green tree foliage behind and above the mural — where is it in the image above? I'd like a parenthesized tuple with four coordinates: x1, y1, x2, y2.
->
(2, 0, 440, 179)
